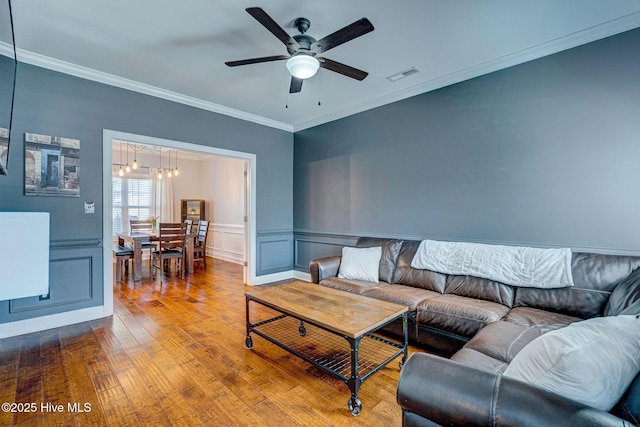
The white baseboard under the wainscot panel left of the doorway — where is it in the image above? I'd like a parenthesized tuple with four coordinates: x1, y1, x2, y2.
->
(0, 305, 110, 339)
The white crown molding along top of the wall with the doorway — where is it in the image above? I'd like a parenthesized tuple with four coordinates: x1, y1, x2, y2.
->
(16, 49, 293, 132)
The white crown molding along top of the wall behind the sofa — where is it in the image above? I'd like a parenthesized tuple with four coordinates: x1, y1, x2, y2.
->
(293, 12, 640, 133)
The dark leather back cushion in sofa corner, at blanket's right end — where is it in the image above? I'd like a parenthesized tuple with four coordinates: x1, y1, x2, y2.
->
(513, 252, 640, 319)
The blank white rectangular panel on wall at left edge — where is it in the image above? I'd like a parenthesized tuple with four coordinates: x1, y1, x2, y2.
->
(0, 212, 49, 301)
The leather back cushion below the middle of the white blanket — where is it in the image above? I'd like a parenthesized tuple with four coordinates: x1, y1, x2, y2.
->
(444, 276, 515, 307)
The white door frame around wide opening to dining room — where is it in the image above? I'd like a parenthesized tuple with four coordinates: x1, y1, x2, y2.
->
(102, 129, 257, 315)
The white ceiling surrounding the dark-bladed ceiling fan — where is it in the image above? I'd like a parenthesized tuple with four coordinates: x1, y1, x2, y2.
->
(7, 0, 640, 131)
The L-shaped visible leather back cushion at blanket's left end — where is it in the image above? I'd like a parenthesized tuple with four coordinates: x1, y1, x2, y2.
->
(393, 240, 447, 293)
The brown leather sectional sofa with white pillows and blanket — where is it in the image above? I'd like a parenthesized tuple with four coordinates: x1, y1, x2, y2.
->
(310, 237, 640, 426)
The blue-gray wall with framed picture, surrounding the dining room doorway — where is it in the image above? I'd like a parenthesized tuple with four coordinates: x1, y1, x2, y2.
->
(0, 63, 293, 322)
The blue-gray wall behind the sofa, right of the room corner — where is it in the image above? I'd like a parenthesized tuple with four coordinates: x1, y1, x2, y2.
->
(294, 30, 640, 270)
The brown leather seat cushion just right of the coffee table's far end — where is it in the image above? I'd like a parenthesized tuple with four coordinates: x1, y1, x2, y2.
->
(416, 295, 509, 338)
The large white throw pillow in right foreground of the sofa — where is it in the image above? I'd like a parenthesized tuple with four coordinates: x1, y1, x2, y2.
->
(504, 315, 640, 412)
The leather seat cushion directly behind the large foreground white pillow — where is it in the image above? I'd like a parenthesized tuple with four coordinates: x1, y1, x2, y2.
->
(464, 320, 542, 363)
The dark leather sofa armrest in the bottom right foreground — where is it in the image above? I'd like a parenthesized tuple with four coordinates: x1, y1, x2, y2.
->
(397, 353, 629, 426)
